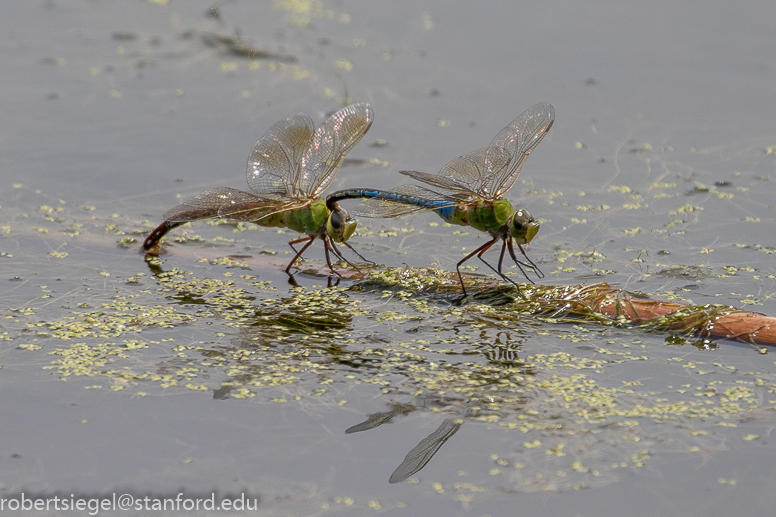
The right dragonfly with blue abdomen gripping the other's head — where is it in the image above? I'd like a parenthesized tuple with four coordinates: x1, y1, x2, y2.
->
(326, 102, 555, 296)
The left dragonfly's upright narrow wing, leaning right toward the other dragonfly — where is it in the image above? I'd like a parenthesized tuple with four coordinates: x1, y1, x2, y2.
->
(302, 102, 374, 199)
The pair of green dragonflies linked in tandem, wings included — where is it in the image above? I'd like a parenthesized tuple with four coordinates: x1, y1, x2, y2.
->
(143, 102, 555, 295)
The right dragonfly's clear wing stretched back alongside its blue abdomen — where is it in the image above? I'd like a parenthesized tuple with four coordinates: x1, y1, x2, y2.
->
(351, 185, 458, 218)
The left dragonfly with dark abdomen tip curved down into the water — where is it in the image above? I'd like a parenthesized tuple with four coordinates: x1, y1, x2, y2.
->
(143, 103, 374, 279)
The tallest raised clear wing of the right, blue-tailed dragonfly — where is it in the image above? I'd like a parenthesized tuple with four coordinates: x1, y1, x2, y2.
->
(478, 102, 555, 199)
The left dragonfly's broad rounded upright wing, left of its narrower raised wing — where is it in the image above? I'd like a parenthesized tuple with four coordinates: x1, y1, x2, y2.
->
(247, 113, 315, 199)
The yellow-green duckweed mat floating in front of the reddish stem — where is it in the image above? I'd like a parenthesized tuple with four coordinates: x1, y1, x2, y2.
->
(4, 258, 776, 497)
